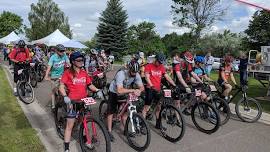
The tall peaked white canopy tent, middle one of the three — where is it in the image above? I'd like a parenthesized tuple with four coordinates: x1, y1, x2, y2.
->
(32, 29, 70, 46)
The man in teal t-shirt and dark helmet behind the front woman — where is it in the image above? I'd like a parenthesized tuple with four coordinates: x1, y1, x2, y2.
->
(45, 44, 70, 112)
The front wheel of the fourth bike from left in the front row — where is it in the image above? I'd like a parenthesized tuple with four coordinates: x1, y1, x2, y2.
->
(191, 102, 220, 134)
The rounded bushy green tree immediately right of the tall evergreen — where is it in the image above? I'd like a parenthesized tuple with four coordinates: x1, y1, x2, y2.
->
(127, 21, 166, 54)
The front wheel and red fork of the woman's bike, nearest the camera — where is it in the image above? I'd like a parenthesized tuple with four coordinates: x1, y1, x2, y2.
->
(79, 118, 111, 152)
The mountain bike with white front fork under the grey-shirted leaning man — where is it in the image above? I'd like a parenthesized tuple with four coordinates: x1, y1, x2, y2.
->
(99, 93, 151, 151)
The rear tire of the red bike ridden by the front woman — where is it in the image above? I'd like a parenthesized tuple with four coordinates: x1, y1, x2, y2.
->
(54, 102, 67, 140)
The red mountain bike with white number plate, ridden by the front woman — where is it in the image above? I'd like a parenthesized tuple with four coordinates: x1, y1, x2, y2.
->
(54, 97, 111, 152)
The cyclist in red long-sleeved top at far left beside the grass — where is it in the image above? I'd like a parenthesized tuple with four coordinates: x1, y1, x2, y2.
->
(9, 40, 30, 95)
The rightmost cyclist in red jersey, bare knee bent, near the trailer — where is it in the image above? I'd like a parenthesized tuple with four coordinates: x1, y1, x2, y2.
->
(218, 55, 237, 101)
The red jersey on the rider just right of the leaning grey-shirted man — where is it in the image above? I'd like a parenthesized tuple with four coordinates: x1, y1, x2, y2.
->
(144, 63, 166, 91)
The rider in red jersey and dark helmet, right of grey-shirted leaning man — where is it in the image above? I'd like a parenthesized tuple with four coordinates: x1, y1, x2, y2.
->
(142, 53, 176, 129)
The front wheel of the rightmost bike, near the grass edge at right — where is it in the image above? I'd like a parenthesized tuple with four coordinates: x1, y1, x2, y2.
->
(235, 97, 262, 123)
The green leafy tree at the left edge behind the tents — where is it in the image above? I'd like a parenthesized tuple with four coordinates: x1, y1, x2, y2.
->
(0, 11, 23, 37)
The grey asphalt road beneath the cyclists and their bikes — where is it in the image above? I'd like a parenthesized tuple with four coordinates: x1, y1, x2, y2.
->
(2, 60, 270, 152)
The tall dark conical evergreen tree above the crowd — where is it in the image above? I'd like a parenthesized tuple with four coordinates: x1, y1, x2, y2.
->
(97, 0, 128, 55)
